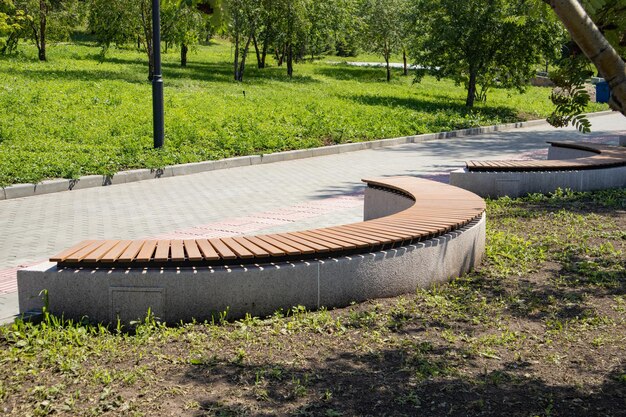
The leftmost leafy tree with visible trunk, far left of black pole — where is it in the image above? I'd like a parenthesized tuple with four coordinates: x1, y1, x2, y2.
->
(13, 0, 80, 61)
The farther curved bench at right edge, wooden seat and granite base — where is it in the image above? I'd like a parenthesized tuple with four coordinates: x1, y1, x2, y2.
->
(450, 142, 626, 198)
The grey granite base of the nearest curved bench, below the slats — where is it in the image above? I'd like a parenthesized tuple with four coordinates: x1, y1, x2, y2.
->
(13, 215, 485, 323)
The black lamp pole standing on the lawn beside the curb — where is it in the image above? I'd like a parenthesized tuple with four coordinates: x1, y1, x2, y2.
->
(152, 0, 165, 148)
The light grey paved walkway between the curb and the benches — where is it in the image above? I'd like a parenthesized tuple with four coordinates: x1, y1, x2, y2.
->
(0, 114, 626, 321)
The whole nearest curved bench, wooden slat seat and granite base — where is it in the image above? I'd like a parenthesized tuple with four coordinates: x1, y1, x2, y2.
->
(17, 177, 485, 322)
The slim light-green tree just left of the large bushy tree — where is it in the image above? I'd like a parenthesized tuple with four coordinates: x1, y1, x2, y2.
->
(364, 0, 408, 81)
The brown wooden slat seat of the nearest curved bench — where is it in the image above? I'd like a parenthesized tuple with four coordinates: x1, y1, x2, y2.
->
(50, 177, 485, 267)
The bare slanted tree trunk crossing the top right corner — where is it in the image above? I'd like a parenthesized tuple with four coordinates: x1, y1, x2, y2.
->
(544, 0, 626, 116)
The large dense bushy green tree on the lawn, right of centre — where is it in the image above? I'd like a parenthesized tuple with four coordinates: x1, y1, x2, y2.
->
(412, 0, 561, 107)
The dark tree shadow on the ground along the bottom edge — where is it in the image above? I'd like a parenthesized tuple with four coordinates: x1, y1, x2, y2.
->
(180, 346, 626, 417)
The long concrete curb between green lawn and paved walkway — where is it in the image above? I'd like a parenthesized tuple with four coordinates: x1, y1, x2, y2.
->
(0, 110, 613, 200)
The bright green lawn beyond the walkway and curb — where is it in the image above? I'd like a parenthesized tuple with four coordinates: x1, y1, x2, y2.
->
(0, 41, 606, 186)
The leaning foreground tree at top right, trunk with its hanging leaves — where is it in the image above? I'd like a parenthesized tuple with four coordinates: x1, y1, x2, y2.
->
(544, 0, 626, 118)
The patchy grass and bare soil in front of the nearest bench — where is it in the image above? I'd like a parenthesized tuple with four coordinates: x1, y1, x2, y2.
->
(0, 189, 626, 417)
